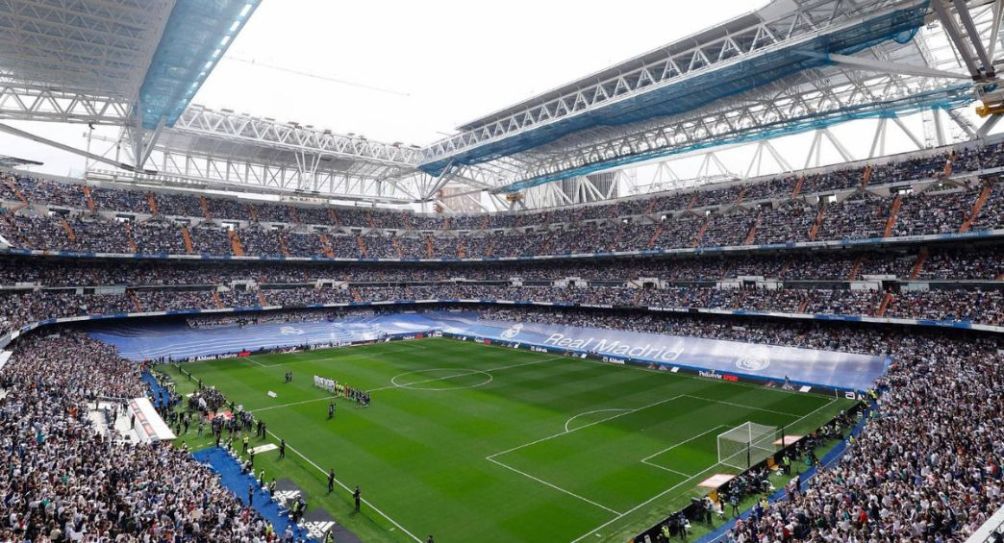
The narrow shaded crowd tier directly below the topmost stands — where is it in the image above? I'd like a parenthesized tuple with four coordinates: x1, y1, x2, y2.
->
(0, 245, 1004, 287)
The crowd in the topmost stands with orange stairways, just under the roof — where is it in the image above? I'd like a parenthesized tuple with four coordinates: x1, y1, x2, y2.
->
(0, 144, 1004, 259)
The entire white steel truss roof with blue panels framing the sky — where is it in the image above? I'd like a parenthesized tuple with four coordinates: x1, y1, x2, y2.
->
(0, 0, 1004, 209)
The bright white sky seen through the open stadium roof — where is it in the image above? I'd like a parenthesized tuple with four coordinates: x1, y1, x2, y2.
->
(0, 0, 765, 176)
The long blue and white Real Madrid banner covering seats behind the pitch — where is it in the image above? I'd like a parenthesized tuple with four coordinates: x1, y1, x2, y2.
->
(90, 311, 889, 390)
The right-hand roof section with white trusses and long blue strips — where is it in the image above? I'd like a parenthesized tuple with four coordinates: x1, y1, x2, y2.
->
(421, 0, 973, 191)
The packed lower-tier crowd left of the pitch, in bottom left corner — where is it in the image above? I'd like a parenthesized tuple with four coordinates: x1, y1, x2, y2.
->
(0, 330, 289, 543)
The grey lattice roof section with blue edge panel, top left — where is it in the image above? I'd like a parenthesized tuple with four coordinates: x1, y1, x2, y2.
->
(0, 0, 260, 128)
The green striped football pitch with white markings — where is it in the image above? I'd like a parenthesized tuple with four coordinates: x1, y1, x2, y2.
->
(161, 338, 852, 543)
